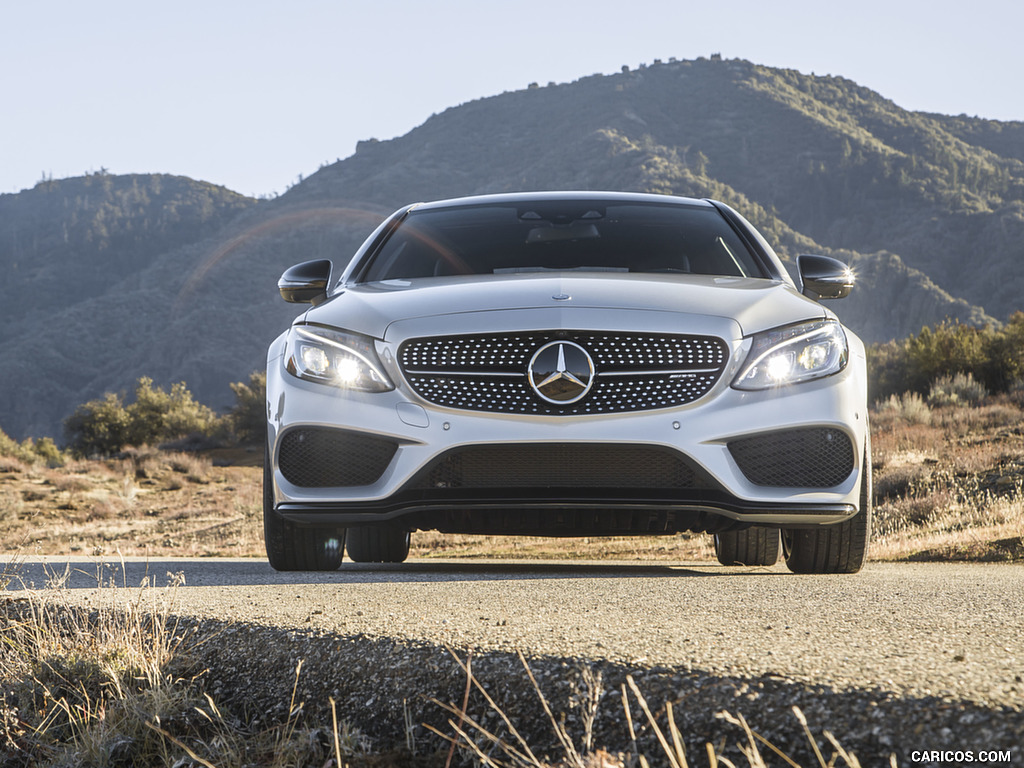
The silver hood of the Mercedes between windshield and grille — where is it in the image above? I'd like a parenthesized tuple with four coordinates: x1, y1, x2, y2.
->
(304, 272, 828, 339)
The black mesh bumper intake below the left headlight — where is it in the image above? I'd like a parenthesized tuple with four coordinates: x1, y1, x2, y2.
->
(278, 427, 397, 487)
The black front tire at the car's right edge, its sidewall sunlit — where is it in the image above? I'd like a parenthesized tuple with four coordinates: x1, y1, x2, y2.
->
(782, 438, 872, 573)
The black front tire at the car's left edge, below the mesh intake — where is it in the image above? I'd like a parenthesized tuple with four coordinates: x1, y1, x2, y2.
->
(263, 445, 345, 570)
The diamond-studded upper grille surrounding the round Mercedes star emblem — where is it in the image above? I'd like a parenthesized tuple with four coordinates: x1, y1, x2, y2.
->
(398, 331, 729, 416)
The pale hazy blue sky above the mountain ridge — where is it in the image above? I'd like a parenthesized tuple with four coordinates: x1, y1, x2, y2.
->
(0, 0, 1024, 196)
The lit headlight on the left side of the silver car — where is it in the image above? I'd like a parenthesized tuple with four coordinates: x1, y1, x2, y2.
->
(285, 326, 394, 392)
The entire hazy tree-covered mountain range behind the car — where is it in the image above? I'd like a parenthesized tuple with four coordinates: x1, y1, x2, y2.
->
(0, 59, 1024, 437)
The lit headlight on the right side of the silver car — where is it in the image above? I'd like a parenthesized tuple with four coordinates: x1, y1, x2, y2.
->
(732, 321, 849, 389)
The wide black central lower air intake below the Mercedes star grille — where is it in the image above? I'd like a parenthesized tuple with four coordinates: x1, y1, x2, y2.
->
(417, 443, 697, 488)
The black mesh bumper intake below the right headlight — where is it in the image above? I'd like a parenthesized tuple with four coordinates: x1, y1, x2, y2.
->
(729, 427, 853, 488)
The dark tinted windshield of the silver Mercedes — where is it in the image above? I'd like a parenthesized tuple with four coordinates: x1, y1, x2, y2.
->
(357, 201, 767, 283)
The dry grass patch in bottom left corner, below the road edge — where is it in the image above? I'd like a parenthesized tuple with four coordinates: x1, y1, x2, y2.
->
(0, 564, 362, 768)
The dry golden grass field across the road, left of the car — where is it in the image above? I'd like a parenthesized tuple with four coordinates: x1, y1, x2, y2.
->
(0, 449, 264, 557)
